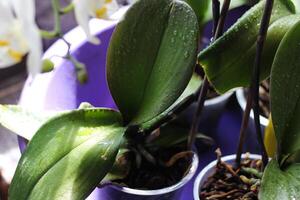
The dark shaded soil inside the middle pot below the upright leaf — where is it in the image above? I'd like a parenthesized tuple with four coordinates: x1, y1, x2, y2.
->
(116, 147, 193, 190)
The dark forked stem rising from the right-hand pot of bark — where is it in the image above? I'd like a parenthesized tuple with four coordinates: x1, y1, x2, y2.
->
(236, 0, 274, 167)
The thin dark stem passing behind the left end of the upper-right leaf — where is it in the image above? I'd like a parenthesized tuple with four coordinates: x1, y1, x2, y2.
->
(187, 0, 231, 150)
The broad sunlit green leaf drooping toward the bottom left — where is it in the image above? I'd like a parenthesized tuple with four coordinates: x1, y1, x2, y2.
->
(9, 109, 124, 200)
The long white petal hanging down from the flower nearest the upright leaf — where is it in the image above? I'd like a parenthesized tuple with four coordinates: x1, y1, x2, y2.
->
(73, 0, 100, 44)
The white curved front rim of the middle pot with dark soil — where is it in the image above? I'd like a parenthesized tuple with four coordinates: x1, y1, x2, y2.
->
(108, 153, 199, 196)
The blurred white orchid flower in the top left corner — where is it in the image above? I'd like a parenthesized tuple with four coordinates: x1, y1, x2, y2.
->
(0, 0, 42, 77)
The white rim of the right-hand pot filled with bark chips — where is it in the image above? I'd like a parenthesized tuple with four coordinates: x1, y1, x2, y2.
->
(193, 154, 261, 200)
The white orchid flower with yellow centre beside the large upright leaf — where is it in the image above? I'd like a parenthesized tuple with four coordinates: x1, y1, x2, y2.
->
(73, 0, 119, 44)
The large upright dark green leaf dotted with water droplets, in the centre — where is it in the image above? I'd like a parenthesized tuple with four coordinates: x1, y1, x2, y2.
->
(107, 0, 199, 124)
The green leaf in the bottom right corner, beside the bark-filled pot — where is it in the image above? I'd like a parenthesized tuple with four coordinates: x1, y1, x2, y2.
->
(259, 160, 300, 200)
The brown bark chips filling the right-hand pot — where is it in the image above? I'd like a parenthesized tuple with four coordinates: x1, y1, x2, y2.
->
(199, 151, 262, 200)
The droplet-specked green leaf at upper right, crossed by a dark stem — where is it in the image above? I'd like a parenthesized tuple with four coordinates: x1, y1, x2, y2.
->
(198, 0, 298, 93)
